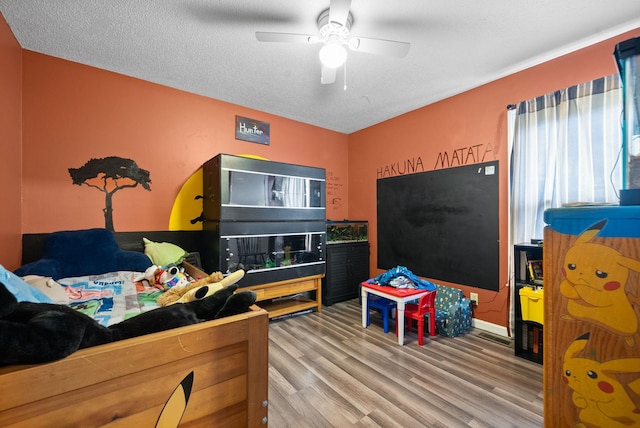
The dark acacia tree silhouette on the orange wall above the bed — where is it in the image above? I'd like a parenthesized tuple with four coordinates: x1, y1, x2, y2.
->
(69, 156, 151, 231)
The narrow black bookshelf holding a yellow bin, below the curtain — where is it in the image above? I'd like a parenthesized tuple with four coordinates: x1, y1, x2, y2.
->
(513, 244, 544, 364)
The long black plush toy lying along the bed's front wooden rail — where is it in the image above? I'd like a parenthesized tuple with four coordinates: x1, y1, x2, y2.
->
(0, 282, 256, 366)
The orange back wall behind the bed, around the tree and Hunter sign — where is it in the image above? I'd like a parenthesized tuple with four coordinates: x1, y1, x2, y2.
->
(22, 51, 348, 233)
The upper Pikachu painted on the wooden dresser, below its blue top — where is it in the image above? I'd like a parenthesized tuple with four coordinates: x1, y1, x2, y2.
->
(560, 220, 640, 346)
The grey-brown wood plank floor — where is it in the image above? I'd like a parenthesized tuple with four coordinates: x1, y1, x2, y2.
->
(269, 299, 542, 428)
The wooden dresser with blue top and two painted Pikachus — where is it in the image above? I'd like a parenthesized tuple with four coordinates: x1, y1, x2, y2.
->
(543, 206, 640, 428)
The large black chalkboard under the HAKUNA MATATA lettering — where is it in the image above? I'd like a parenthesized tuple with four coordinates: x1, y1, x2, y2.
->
(377, 161, 500, 291)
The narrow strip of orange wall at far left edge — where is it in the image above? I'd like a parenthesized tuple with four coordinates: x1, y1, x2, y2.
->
(0, 14, 22, 270)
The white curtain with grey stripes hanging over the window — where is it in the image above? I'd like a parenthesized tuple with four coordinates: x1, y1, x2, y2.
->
(510, 74, 622, 244)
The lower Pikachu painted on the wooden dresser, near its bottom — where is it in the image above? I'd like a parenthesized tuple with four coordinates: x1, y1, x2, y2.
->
(562, 333, 640, 428)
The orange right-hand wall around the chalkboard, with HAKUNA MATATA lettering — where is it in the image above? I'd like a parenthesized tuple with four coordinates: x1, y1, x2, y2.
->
(349, 31, 638, 326)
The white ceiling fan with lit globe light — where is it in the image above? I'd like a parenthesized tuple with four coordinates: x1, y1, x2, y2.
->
(256, 0, 411, 88)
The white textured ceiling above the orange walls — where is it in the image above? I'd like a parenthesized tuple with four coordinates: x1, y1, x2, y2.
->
(0, 0, 640, 134)
